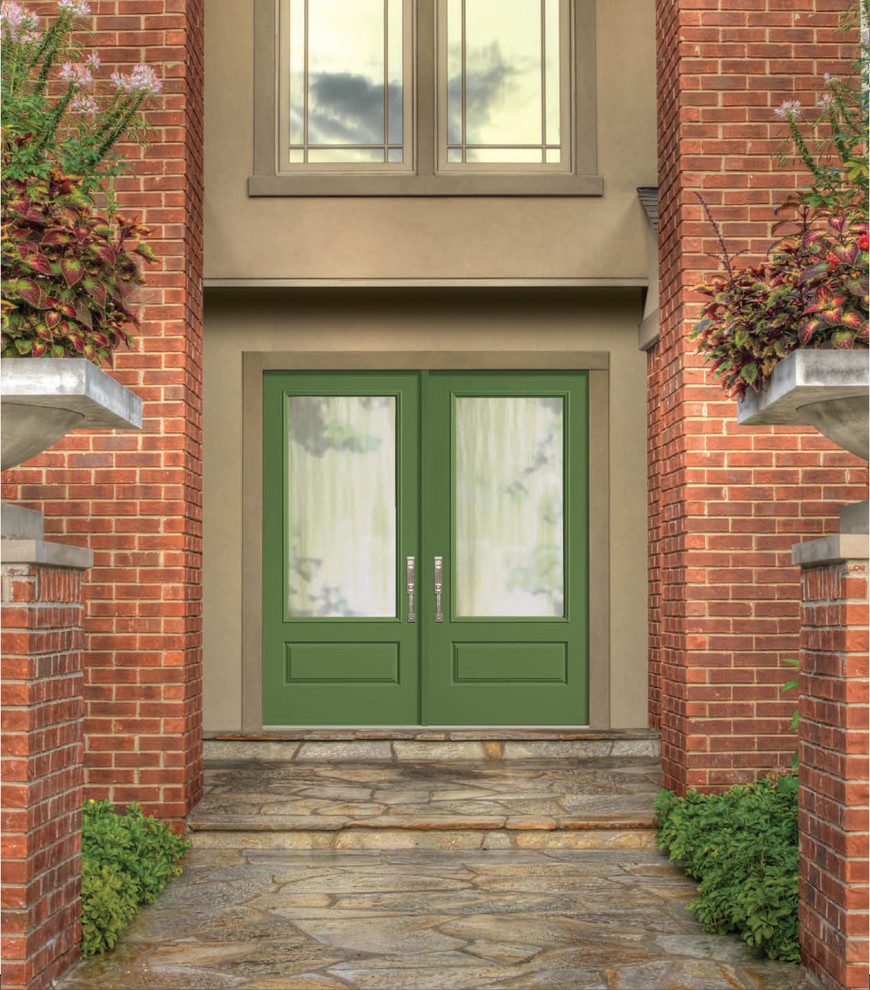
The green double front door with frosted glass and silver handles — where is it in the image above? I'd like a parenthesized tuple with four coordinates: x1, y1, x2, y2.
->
(263, 371, 589, 726)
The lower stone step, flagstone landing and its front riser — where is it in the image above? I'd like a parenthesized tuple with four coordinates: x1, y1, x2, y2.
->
(187, 756, 660, 849)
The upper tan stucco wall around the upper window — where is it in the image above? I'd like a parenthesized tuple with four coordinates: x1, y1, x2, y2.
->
(205, 0, 656, 284)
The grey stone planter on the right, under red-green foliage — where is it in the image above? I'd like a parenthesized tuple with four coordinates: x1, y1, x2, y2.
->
(737, 349, 870, 460)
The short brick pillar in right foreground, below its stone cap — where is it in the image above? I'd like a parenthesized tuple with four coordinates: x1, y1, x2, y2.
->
(799, 560, 870, 990)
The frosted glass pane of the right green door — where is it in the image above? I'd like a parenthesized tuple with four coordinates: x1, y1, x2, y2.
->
(455, 397, 564, 616)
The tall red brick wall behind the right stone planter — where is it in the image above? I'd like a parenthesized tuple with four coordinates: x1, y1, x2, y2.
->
(649, 0, 867, 791)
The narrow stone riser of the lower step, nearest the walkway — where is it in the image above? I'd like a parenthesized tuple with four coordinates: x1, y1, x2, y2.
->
(188, 828, 658, 851)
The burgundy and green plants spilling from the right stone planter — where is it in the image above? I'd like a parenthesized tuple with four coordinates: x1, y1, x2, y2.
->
(690, 0, 870, 398)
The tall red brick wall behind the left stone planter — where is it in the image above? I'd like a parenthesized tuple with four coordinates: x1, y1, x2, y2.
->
(3, 0, 204, 818)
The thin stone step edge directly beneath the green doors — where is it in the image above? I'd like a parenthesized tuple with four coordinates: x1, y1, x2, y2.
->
(203, 736, 660, 763)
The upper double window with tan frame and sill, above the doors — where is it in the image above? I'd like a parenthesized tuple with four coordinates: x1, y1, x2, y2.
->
(248, 0, 602, 196)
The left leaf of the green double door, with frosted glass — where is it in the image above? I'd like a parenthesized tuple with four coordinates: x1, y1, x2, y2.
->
(263, 372, 420, 726)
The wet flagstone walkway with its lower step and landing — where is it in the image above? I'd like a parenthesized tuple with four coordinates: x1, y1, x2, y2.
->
(57, 750, 807, 990)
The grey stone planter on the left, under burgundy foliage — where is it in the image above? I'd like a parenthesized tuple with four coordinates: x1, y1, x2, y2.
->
(0, 358, 142, 471)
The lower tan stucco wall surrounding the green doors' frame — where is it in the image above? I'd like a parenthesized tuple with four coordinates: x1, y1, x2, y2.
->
(203, 289, 647, 730)
